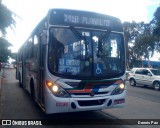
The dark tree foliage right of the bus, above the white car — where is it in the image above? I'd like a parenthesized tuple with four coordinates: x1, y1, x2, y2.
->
(123, 12, 160, 67)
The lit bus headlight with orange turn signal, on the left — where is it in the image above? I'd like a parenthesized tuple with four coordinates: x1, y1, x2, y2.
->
(46, 81, 70, 98)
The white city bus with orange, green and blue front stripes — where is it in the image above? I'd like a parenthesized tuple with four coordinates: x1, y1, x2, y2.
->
(16, 9, 126, 114)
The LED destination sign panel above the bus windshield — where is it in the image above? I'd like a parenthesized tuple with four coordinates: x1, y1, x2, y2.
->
(49, 9, 123, 32)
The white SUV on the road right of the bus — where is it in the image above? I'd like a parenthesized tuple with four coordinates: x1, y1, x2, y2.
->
(128, 68, 160, 90)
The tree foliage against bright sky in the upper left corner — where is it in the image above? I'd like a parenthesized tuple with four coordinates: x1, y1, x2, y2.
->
(0, 1, 16, 36)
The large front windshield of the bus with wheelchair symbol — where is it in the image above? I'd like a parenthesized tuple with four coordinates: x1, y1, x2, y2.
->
(48, 27, 125, 78)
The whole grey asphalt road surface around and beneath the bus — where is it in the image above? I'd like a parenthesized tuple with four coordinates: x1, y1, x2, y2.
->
(0, 69, 160, 128)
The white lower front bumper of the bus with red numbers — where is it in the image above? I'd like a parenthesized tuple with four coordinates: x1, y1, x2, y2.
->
(45, 90, 126, 114)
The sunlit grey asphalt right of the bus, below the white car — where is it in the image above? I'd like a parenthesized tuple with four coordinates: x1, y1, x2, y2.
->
(104, 82, 160, 119)
